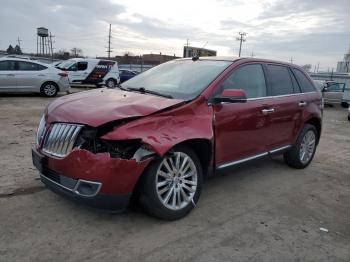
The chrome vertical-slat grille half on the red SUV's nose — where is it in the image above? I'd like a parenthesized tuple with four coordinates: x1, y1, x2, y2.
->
(43, 123, 83, 157)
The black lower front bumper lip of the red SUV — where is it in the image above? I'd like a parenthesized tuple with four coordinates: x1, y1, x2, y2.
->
(40, 170, 131, 212)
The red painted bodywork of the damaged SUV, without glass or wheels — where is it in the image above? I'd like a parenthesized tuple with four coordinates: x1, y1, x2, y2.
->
(36, 59, 322, 201)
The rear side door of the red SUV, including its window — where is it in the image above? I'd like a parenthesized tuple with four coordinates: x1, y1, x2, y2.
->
(265, 64, 307, 151)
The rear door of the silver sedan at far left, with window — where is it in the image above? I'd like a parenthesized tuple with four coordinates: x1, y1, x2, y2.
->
(16, 61, 47, 92)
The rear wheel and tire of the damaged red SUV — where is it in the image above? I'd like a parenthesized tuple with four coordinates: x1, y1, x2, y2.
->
(283, 124, 318, 169)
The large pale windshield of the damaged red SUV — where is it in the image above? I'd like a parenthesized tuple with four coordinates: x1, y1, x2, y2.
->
(121, 60, 232, 100)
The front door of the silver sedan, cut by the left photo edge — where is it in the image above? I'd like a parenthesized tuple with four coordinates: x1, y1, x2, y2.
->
(0, 60, 16, 91)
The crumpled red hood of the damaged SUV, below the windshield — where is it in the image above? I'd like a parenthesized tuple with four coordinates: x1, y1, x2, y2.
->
(46, 88, 184, 127)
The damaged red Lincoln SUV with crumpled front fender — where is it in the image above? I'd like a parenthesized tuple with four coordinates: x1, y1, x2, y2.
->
(32, 57, 323, 220)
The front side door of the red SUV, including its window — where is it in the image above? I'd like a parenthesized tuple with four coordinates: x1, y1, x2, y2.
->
(213, 64, 271, 167)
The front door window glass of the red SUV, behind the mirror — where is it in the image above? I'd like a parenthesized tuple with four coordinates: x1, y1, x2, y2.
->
(220, 64, 266, 98)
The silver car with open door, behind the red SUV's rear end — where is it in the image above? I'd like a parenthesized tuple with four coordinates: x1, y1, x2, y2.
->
(314, 80, 349, 107)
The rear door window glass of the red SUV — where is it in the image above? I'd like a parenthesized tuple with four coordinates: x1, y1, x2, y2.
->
(266, 65, 294, 96)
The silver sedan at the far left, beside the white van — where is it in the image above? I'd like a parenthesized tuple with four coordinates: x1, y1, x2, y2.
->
(0, 57, 70, 97)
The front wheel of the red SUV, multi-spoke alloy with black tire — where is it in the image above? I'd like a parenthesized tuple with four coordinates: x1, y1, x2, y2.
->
(140, 146, 203, 220)
